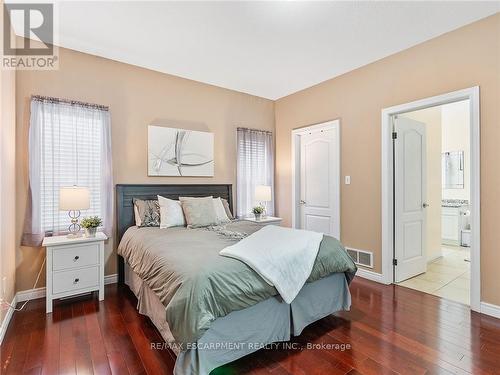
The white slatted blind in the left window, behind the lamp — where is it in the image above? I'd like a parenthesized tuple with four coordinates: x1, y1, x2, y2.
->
(40, 111, 104, 232)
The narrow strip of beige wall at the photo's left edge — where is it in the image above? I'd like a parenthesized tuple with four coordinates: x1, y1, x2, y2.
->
(0, 8, 16, 323)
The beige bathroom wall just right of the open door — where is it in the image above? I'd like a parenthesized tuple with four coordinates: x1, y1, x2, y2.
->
(401, 106, 442, 262)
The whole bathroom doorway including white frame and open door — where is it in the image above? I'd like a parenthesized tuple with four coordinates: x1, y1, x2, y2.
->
(382, 87, 481, 312)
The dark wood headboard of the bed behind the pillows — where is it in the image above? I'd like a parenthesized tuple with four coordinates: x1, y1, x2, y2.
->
(116, 184, 234, 283)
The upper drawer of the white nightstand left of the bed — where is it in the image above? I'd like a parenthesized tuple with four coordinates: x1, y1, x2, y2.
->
(52, 242, 99, 271)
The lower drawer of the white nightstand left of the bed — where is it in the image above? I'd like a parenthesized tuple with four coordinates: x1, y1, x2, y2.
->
(52, 266, 99, 294)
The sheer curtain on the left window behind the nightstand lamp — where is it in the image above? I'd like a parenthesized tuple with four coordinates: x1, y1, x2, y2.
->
(22, 97, 113, 246)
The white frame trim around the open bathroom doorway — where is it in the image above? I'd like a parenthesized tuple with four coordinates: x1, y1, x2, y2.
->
(382, 86, 481, 312)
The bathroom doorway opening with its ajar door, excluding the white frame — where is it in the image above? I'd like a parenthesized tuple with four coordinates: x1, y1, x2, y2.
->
(394, 100, 471, 305)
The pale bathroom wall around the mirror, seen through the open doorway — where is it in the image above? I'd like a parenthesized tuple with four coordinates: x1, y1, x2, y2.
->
(441, 100, 470, 200)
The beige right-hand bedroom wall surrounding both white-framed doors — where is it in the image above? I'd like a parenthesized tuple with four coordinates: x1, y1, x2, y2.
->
(275, 14, 500, 305)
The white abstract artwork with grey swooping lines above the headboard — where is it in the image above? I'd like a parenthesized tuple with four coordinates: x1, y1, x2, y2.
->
(148, 125, 214, 177)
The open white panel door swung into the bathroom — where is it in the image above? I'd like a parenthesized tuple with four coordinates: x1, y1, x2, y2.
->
(394, 118, 427, 282)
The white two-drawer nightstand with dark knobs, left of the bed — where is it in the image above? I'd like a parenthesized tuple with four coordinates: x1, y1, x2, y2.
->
(42, 232, 108, 314)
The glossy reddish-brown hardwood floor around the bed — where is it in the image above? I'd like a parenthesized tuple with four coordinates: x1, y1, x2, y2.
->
(1, 278, 500, 375)
